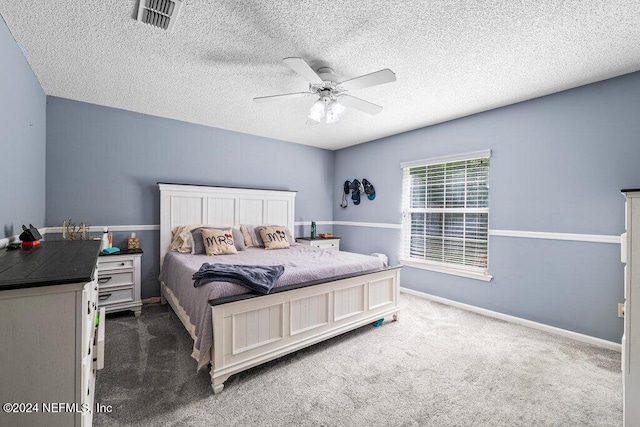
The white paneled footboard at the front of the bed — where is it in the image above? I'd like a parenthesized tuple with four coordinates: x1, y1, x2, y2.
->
(211, 268, 400, 393)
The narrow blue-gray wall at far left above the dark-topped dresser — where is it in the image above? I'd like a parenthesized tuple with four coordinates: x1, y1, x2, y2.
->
(0, 17, 46, 239)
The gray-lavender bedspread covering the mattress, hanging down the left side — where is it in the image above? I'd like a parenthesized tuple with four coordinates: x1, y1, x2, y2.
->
(160, 244, 383, 369)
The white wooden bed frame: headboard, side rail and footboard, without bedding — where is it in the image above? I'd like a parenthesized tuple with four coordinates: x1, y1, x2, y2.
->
(159, 184, 400, 393)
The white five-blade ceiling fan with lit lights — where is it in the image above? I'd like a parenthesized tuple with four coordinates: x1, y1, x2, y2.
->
(253, 58, 396, 124)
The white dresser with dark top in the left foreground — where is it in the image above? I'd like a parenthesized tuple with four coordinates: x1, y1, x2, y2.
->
(0, 241, 105, 427)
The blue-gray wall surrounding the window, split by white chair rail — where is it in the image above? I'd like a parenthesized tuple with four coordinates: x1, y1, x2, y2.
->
(334, 73, 640, 342)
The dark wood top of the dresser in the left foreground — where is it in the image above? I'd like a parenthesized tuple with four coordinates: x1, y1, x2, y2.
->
(0, 240, 100, 291)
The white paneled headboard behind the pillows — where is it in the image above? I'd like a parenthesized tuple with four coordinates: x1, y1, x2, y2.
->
(158, 183, 296, 265)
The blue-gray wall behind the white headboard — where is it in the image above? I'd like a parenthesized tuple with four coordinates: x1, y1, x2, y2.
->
(46, 96, 334, 298)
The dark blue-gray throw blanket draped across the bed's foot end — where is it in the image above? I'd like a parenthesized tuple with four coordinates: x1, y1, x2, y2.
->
(193, 262, 284, 294)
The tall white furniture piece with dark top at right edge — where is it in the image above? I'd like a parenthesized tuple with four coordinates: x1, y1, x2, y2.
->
(621, 189, 640, 427)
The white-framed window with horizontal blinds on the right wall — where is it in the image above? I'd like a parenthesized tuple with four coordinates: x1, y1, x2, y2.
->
(400, 150, 491, 280)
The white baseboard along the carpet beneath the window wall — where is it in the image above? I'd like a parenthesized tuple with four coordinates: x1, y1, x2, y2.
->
(400, 287, 622, 352)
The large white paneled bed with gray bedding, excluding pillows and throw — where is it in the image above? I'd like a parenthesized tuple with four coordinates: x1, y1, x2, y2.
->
(159, 183, 400, 393)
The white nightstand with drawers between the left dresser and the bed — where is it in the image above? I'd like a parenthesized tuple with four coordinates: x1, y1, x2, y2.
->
(98, 249, 142, 316)
